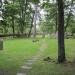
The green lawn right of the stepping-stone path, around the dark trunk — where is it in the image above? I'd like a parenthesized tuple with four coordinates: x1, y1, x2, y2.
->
(27, 39, 75, 75)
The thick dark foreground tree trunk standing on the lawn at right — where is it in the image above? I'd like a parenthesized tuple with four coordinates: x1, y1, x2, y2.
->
(57, 0, 66, 63)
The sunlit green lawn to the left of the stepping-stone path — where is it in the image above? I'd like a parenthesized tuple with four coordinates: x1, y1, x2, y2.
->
(0, 39, 41, 75)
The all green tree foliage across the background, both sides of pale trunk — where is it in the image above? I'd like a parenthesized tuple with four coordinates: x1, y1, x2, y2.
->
(0, 0, 75, 34)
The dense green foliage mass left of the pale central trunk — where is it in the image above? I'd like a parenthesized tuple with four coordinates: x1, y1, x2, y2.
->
(1, 0, 34, 33)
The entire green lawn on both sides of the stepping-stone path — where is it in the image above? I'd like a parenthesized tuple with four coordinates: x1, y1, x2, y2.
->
(0, 38, 75, 75)
